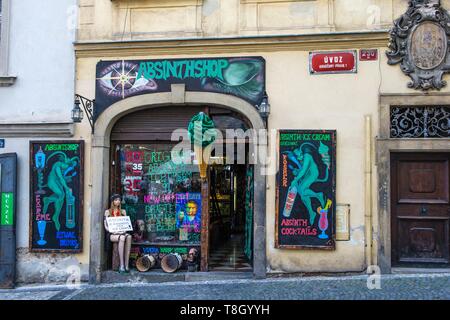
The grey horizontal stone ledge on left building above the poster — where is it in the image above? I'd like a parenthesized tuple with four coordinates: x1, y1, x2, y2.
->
(0, 122, 74, 138)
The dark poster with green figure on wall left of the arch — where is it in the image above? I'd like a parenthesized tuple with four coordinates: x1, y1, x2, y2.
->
(29, 141, 84, 252)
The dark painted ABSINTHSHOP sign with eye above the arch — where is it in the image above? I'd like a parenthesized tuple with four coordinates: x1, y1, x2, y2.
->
(94, 57, 265, 119)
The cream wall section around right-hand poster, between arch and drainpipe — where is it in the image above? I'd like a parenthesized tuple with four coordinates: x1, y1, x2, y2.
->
(266, 52, 380, 272)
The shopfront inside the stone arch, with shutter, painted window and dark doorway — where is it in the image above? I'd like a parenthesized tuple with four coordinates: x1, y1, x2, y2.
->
(107, 106, 253, 271)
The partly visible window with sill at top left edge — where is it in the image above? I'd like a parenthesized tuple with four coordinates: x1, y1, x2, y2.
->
(0, 0, 15, 86)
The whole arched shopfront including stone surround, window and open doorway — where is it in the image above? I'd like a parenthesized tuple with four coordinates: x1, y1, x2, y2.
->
(90, 88, 266, 282)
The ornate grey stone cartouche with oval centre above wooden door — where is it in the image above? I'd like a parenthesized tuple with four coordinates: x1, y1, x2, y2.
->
(386, 0, 450, 91)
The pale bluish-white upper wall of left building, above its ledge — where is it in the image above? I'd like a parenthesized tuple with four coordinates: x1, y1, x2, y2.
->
(0, 0, 76, 122)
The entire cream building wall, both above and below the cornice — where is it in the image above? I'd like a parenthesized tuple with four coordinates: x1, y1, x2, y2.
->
(76, 0, 450, 273)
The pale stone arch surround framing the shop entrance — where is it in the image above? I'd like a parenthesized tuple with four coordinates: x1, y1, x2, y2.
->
(89, 84, 267, 283)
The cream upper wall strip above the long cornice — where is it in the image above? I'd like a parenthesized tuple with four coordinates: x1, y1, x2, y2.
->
(78, 0, 450, 41)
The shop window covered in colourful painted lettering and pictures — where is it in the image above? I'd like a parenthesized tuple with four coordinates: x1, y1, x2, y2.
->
(119, 144, 202, 246)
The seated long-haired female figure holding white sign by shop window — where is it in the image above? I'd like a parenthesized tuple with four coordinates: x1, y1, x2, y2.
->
(104, 194, 131, 273)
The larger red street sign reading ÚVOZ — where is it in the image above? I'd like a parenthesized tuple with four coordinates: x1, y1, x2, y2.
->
(309, 51, 356, 74)
